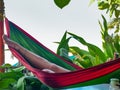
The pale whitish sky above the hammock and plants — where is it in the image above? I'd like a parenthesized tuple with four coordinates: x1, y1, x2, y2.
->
(4, 0, 109, 90)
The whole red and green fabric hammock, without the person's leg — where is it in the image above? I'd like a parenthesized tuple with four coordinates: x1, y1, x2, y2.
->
(5, 19, 120, 88)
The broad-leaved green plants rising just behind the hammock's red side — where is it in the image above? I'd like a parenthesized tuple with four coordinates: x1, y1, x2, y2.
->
(57, 21, 120, 68)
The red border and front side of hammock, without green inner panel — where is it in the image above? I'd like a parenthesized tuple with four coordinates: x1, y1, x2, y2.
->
(5, 19, 120, 88)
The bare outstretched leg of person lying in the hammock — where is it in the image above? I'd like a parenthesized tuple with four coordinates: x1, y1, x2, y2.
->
(3, 35, 70, 73)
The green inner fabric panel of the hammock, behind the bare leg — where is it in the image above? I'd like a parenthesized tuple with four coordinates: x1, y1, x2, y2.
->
(5, 19, 79, 70)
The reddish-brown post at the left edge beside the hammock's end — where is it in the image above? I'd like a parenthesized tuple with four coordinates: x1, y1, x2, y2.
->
(0, 0, 4, 72)
